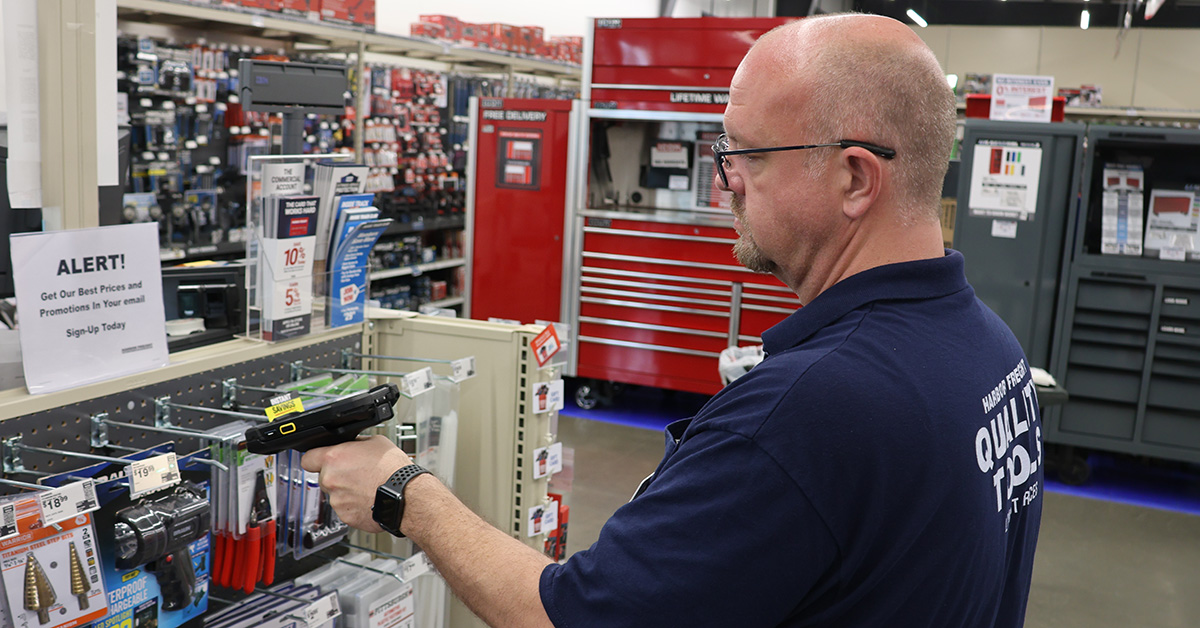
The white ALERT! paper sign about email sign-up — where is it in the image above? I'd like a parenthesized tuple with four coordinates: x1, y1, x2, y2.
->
(11, 222, 168, 394)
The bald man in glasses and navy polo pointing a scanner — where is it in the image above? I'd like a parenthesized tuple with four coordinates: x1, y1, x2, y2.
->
(304, 16, 1042, 628)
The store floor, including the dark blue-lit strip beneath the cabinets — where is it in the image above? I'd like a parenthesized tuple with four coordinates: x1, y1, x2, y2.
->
(556, 389, 1200, 628)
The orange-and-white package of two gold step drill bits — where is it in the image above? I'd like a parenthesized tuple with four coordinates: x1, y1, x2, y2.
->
(0, 496, 108, 628)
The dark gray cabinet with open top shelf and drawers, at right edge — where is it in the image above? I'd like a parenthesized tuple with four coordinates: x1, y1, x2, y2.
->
(1043, 126, 1200, 462)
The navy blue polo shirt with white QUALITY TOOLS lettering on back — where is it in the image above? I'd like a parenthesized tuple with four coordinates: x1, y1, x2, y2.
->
(540, 251, 1043, 628)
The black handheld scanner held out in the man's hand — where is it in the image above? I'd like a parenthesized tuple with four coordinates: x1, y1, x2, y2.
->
(246, 384, 400, 454)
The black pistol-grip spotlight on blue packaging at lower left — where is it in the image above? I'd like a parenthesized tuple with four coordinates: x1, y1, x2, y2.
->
(113, 482, 212, 610)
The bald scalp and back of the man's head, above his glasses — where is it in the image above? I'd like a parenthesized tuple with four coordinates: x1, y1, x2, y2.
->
(731, 14, 956, 221)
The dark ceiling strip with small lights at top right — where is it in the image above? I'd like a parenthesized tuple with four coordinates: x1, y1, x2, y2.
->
(775, 0, 1200, 29)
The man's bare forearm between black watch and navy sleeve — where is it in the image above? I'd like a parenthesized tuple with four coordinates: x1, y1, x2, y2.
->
(401, 474, 553, 628)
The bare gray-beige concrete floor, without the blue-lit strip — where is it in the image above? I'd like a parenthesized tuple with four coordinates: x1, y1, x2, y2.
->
(558, 415, 1200, 628)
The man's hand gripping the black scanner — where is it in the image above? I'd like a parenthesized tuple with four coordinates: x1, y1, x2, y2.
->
(300, 436, 413, 532)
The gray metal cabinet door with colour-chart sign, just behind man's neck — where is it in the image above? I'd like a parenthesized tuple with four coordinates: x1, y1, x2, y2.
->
(954, 119, 1086, 372)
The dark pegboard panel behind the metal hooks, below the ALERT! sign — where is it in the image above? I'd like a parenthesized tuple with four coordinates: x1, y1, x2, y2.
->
(0, 334, 362, 494)
